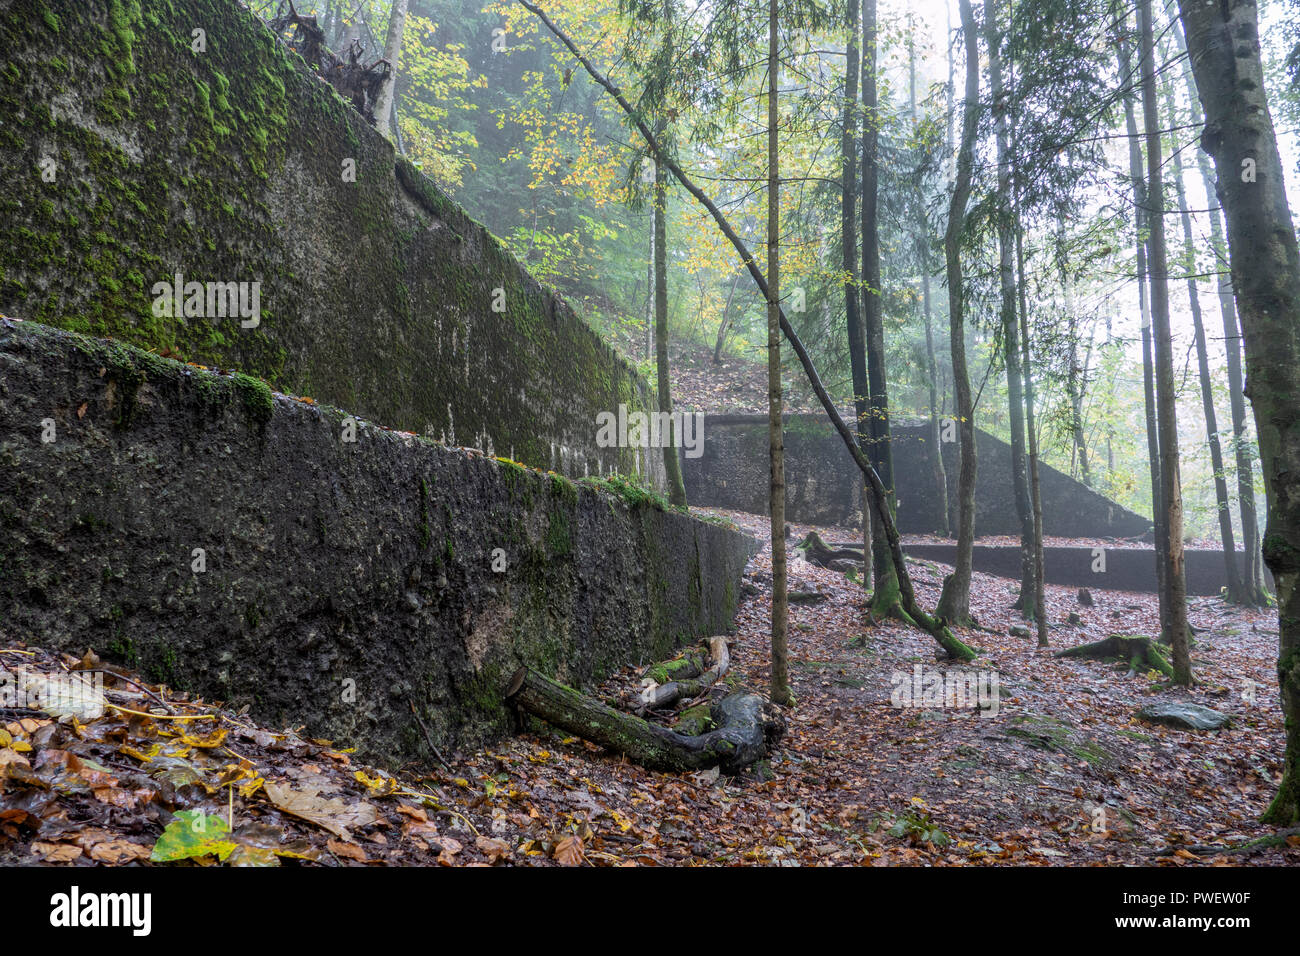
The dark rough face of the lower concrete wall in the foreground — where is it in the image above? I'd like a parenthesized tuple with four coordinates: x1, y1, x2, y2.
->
(0, 320, 757, 760)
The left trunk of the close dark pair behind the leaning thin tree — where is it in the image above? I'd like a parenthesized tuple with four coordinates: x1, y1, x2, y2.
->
(840, 0, 871, 587)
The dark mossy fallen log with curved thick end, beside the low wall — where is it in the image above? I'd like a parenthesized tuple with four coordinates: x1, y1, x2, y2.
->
(506, 667, 785, 774)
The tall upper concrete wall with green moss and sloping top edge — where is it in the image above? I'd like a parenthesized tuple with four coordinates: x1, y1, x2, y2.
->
(0, 0, 663, 486)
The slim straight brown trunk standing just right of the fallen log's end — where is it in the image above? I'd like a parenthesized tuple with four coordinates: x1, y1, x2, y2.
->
(767, 0, 790, 704)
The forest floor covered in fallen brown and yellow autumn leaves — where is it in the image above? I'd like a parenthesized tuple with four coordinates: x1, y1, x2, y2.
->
(0, 512, 1300, 866)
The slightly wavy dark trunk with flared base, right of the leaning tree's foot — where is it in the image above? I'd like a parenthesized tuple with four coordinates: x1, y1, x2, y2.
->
(937, 0, 979, 624)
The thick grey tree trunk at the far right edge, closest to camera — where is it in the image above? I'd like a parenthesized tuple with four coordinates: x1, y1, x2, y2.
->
(1178, 0, 1300, 826)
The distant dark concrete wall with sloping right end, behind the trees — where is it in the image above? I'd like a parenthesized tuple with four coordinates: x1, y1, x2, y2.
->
(683, 414, 1151, 537)
